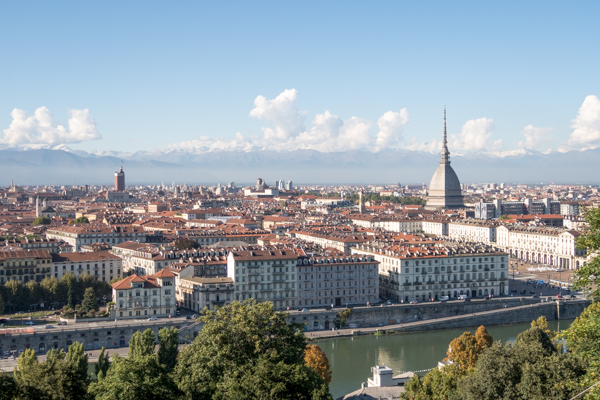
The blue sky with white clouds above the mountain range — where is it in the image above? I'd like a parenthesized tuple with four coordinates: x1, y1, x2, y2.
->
(0, 1, 600, 154)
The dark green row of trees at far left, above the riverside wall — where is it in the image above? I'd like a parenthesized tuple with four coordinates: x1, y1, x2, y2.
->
(0, 274, 113, 313)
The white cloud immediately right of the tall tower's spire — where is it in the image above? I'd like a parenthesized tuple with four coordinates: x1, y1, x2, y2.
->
(448, 118, 502, 152)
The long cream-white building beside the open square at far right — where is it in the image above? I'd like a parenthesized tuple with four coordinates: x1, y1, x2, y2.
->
(497, 226, 586, 269)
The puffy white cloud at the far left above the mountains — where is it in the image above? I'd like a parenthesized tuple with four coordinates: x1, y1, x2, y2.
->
(0, 107, 102, 147)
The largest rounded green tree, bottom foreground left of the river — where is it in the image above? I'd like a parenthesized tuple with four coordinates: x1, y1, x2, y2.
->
(174, 299, 331, 399)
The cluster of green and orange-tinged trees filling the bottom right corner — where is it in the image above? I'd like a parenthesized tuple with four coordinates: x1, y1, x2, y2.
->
(402, 314, 600, 400)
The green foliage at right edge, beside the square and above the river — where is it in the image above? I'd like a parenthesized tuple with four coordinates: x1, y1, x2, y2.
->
(573, 207, 600, 301)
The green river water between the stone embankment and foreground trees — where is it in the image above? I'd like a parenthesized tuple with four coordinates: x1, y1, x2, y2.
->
(311, 320, 573, 399)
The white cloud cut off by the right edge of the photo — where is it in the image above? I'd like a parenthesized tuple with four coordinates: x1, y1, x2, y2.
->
(559, 95, 600, 151)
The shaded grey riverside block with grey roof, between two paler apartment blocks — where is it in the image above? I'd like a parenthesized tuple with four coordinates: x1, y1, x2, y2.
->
(296, 255, 379, 307)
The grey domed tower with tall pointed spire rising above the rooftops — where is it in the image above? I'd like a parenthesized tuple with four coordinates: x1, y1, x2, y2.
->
(426, 108, 464, 209)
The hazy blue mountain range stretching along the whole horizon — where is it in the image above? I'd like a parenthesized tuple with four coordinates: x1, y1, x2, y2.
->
(0, 145, 600, 186)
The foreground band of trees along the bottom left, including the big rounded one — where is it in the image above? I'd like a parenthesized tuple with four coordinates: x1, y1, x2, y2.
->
(0, 300, 332, 400)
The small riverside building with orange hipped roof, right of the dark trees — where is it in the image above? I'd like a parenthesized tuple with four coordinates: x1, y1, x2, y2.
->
(111, 270, 177, 319)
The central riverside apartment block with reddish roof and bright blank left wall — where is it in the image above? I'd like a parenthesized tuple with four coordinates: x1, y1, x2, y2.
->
(227, 248, 298, 310)
